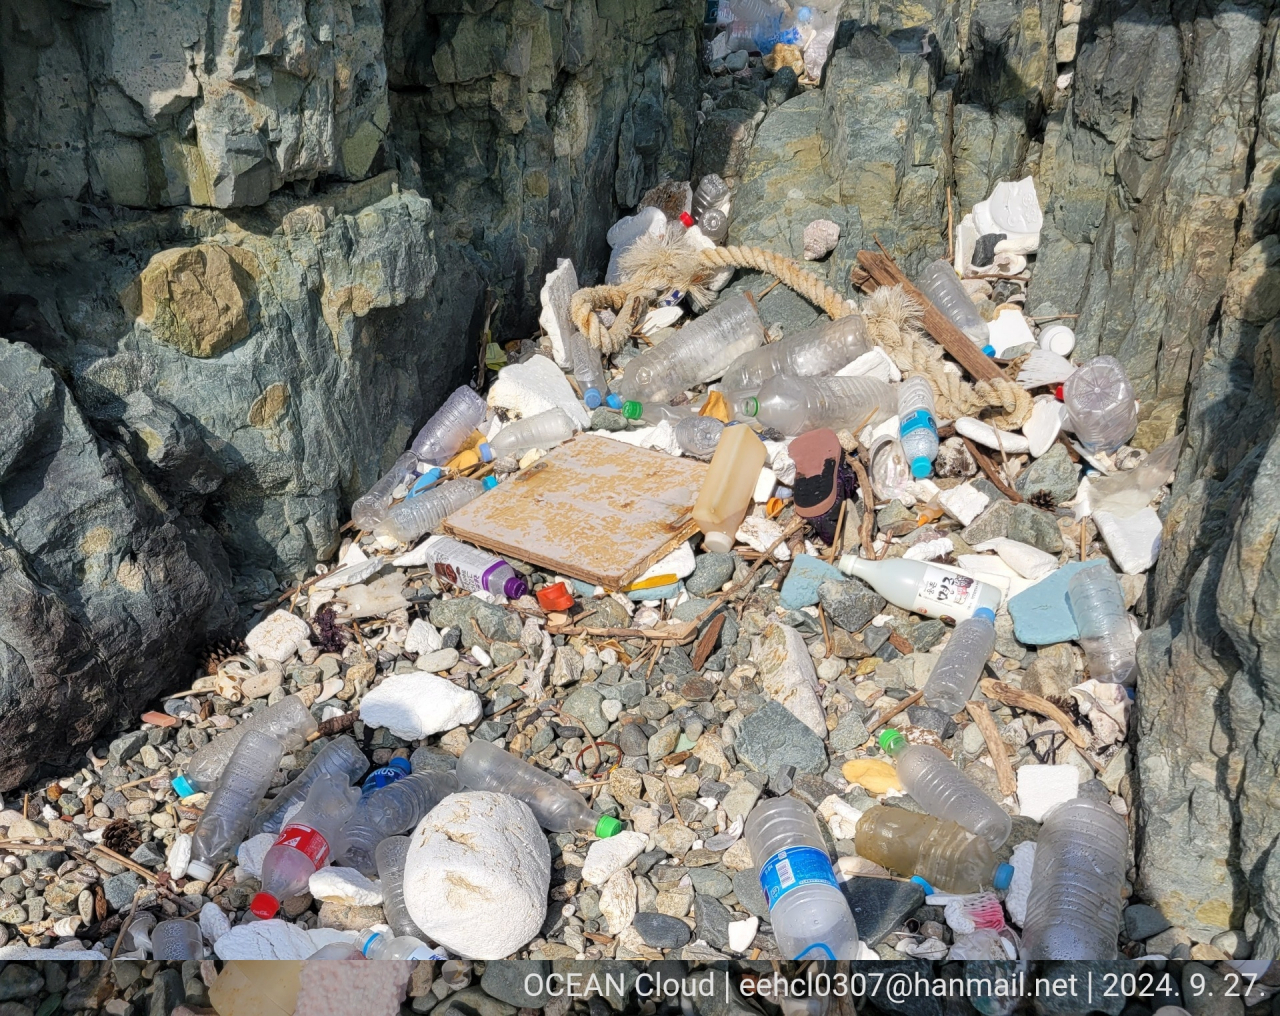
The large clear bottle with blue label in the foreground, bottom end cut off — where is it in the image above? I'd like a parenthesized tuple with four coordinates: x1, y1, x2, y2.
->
(745, 797, 858, 960)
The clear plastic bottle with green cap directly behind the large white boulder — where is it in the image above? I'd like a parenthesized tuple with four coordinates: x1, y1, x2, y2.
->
(458, 741, 622, 839)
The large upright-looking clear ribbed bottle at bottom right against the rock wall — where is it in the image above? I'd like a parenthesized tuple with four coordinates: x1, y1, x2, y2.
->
(1021, 797, 1129, 961)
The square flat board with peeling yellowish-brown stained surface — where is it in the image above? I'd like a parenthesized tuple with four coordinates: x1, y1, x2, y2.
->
(444, 434, 708, 590)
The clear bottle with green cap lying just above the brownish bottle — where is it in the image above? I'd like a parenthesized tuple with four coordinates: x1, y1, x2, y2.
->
(879, 728, 1014, 850)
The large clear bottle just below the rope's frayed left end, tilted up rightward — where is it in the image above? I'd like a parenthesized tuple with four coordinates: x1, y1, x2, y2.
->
(620, 296, 764, 403)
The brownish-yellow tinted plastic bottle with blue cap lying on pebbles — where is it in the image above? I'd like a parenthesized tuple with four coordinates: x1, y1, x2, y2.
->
(854, 805, 1014, 893)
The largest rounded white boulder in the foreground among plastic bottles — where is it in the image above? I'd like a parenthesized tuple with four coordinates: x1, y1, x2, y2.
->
(404, 791, 550, 960)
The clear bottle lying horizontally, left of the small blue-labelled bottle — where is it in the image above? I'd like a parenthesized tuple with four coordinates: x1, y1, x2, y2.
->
(735, 374, 897, 436)
